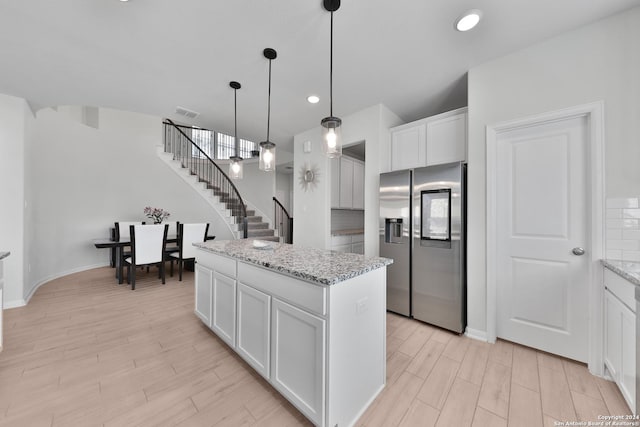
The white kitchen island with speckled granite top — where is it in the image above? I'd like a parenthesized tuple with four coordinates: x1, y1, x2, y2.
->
(195, 239, 393, 427)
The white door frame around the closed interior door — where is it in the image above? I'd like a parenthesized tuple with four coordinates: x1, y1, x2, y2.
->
(486, 101, 604, 376)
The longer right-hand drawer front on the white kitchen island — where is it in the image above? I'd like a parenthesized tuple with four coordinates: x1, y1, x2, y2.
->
(238, 262, 327, 316)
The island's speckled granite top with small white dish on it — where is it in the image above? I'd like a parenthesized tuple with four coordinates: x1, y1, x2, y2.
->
(194, 240, 393, 286)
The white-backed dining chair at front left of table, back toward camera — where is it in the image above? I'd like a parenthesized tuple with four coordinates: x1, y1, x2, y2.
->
(124, 224, 169, 290)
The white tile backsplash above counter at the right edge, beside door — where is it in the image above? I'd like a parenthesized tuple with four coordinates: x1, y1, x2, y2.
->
(605, 197, 640, 262)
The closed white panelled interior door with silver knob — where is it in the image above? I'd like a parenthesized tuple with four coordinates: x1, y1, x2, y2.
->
(495, 116, 591, 361)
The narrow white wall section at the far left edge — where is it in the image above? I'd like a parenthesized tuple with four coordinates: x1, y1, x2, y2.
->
(0, 94, 31, 307)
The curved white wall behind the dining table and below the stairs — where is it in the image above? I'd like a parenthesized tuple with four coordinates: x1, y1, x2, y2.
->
(11, 104, 232, 305)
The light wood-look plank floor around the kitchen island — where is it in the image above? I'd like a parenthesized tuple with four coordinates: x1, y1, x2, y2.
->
(0, 268, 629, 427)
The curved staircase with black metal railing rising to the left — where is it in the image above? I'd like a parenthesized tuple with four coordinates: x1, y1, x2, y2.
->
(158, 119, 280, 242)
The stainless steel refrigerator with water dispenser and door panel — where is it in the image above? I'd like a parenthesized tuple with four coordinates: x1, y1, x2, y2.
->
(380, 163, 466, 333)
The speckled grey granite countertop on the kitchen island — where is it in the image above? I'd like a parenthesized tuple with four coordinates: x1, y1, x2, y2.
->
(194, 239, 393, 285)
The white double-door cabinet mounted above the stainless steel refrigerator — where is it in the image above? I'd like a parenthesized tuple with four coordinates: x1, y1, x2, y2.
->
(390, 107, 467, 171)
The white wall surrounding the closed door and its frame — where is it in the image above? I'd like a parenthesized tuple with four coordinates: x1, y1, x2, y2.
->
(468, 8, 640, 331)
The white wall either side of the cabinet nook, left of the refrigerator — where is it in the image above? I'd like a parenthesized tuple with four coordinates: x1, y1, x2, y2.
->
(293, 104, 403, 256)
